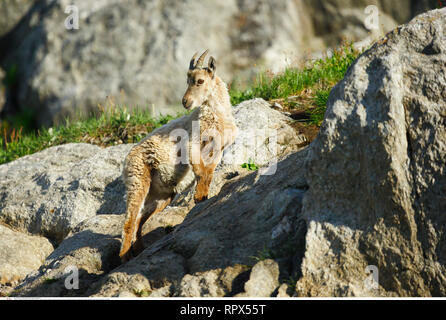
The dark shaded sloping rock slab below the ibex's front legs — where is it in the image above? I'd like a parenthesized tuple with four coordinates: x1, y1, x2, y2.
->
(83, 151, 306, 296)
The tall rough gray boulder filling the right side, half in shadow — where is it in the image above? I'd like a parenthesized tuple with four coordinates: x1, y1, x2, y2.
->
(297, 9, 446, 296)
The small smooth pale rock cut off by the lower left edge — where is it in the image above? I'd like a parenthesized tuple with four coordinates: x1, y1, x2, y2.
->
(0, 224, 53, 286)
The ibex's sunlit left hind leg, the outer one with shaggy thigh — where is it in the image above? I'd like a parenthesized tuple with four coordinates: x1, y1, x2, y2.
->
(119, 148, 151, 262)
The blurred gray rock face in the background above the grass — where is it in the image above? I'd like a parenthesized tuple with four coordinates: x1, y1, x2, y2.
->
(0, 0, 437, 125)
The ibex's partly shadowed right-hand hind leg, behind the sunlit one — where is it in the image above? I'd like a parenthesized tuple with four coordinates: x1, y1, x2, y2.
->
(132, 194, 173, 256)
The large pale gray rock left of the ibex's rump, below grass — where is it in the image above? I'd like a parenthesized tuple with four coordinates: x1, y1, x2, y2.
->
(0, 144, 131, 242)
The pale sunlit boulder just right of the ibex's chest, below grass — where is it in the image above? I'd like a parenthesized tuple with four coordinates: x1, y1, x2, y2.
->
(210, 98, 310, 196)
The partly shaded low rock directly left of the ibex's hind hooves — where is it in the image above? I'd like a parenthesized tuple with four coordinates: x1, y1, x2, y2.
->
(16, 215, 124, 297)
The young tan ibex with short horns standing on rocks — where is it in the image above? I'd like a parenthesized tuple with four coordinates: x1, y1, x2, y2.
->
(119, 50, 237, 262)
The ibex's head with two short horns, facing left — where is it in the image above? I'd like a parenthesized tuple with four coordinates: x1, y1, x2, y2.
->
(182, 50, 216, 110)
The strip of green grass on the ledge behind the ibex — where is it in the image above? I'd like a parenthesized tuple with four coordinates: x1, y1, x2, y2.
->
(0, 45, 359, 165)
